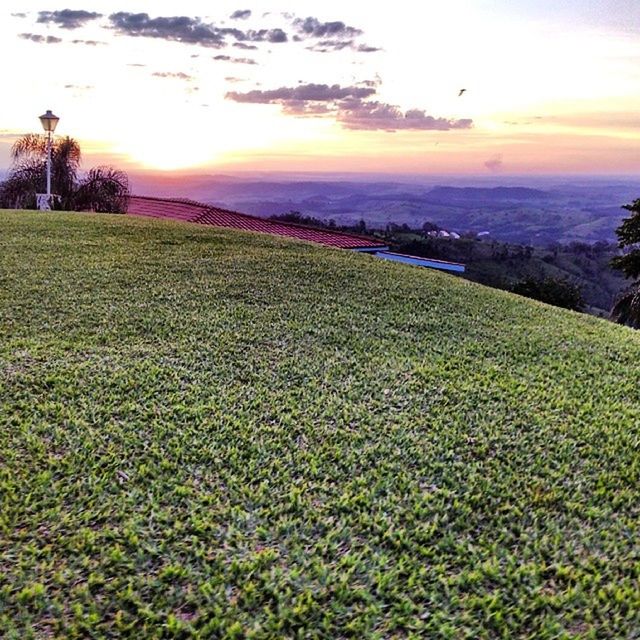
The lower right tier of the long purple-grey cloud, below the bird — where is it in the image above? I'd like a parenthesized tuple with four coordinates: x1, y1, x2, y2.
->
(338, 100, 473, 131)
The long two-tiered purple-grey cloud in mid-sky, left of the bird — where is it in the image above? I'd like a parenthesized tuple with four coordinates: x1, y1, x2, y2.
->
(226, 81, 473, 131)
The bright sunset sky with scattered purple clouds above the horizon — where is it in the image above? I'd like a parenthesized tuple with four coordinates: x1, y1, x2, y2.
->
(0, 0, 640, 175)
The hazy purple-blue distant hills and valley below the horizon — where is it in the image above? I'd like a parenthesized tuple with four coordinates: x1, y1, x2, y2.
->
(132, 175, 640, 245)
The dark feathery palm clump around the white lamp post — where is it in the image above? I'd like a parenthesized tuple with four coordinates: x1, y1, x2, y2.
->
(0, 134, 129, 213)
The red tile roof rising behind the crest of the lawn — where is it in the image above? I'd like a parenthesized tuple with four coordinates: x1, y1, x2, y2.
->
(127, 196, 385, 249)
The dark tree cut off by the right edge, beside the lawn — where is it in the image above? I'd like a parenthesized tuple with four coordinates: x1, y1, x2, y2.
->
(611, 200, 640, 329)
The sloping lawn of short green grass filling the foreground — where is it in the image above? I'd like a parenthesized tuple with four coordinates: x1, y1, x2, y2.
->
(0, 212, 640, 640)
